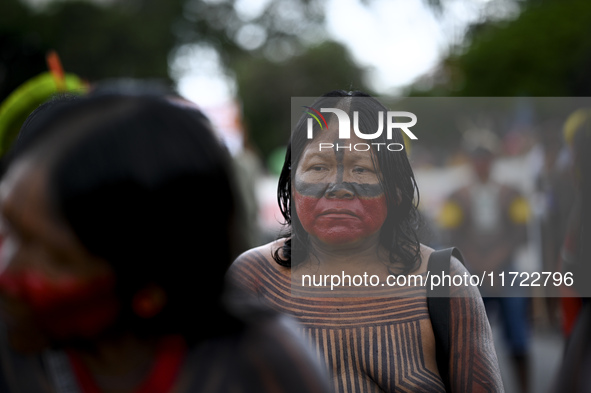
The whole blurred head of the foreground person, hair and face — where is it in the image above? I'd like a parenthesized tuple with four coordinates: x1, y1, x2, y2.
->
(0, 92, 243, 348)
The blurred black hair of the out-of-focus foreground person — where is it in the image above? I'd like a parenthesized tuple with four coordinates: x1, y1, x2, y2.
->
(16, 92, 240, 342)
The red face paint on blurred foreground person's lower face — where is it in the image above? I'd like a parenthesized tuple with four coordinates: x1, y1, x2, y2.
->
(0, 270, 119, 339)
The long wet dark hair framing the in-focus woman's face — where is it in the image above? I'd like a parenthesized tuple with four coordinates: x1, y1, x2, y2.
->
(273, 90, 420, 273)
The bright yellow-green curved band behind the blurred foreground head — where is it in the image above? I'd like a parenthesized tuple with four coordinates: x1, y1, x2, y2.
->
(0, 71, 88, 156)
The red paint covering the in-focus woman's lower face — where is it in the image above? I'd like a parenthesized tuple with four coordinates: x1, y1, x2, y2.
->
(294, 191, 388, 244)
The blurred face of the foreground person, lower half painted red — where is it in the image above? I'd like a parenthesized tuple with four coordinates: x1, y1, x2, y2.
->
(0, 160, 119, 350)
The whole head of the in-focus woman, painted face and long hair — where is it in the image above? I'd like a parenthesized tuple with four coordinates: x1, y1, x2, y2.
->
(274, 90, 420, 271)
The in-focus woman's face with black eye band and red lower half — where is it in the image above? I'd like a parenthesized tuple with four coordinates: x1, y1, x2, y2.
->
(294, 124, 387, 245)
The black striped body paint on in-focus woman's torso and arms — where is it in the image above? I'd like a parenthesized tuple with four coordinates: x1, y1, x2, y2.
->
(229, 250, 503, 393)
